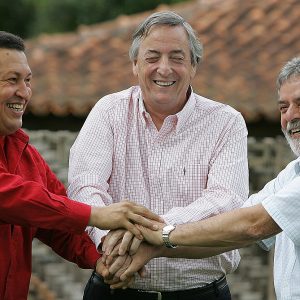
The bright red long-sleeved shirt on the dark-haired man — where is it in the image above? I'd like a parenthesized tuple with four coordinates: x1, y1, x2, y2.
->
(0, 130, 100, 300)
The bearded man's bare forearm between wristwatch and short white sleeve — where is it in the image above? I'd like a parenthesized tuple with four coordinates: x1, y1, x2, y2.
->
(170, 204, 281, 249)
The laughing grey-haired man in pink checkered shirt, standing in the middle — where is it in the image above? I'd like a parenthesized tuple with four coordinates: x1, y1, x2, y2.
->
(68, 12, 248, 300)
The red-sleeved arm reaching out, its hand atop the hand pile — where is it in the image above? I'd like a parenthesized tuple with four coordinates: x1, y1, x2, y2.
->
(0, 156, 159, 235)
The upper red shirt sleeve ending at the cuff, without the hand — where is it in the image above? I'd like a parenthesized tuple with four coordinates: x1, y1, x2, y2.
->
(0, 163, 91, 233)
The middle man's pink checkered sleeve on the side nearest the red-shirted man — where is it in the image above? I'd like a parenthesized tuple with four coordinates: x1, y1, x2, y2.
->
(67, 100, 114, 246)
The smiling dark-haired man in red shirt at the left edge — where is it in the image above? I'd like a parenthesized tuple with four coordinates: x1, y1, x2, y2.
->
(0, 31, 158, 300)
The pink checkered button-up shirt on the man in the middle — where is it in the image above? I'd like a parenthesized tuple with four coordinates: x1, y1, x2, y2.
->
(68, 86, 248, 291)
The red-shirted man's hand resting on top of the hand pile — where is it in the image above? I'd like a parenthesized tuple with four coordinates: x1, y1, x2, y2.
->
(89, 201, 161, 239)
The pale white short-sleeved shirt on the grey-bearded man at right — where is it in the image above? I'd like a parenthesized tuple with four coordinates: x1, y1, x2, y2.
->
(245, 158, 300, 300)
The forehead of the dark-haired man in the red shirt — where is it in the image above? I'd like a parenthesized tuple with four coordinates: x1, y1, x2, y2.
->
(0, 49, 31, 74)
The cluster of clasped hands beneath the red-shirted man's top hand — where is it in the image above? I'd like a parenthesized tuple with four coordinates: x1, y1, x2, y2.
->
(96, 222, 165, 289)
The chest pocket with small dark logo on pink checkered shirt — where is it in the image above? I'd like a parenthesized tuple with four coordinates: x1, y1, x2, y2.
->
(165, 163, 208, 206)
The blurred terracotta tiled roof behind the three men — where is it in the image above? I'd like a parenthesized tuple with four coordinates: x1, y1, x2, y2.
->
(27, 0, 300, 122)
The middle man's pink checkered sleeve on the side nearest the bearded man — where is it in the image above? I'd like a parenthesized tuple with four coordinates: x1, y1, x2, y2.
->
(162, 114, 249, 224)
